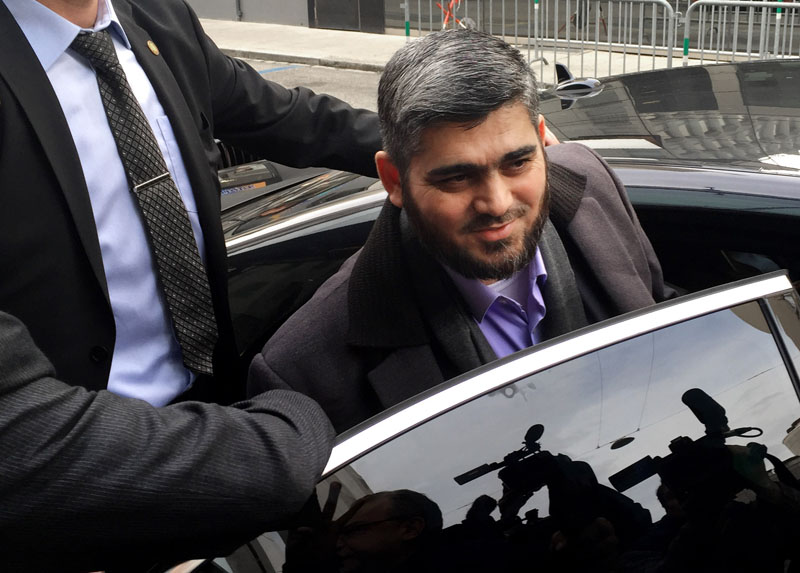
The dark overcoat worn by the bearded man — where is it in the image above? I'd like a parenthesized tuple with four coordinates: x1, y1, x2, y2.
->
(248, 143, 671, 432)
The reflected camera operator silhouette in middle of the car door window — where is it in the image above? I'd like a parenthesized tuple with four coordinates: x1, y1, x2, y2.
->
(454, 418, 651, 571)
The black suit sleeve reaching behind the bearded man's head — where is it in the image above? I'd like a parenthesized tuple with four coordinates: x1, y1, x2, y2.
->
(184, 1, 381, 177)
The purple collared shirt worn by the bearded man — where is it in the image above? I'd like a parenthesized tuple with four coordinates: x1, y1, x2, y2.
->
(445, 248, 547, 358)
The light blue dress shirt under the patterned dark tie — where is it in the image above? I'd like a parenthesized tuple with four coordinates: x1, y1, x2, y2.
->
(3, 0, 205, 406)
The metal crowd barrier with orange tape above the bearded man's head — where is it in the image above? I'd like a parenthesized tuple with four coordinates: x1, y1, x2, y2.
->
(394, 0, 677, 83)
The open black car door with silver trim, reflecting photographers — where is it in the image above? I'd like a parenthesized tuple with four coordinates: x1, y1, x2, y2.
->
(189, 273, 800, 573)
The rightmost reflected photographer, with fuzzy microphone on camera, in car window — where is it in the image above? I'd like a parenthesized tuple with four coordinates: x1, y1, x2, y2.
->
(609, 388, 800, 573)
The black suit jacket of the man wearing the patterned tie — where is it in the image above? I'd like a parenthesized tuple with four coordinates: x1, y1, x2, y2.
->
(0, 0, 380, 389)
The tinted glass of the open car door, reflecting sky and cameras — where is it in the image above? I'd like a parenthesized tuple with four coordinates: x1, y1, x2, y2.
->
(203, 295, 800, 572)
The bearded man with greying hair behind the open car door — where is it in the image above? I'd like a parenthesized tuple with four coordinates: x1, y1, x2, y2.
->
(249, 30, 667, 431)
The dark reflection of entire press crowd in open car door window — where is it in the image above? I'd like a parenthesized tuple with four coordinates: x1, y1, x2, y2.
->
(283, 389, 800, 573)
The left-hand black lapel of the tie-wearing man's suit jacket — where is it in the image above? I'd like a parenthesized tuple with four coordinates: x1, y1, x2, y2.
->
(0, 3, 108, 300)
